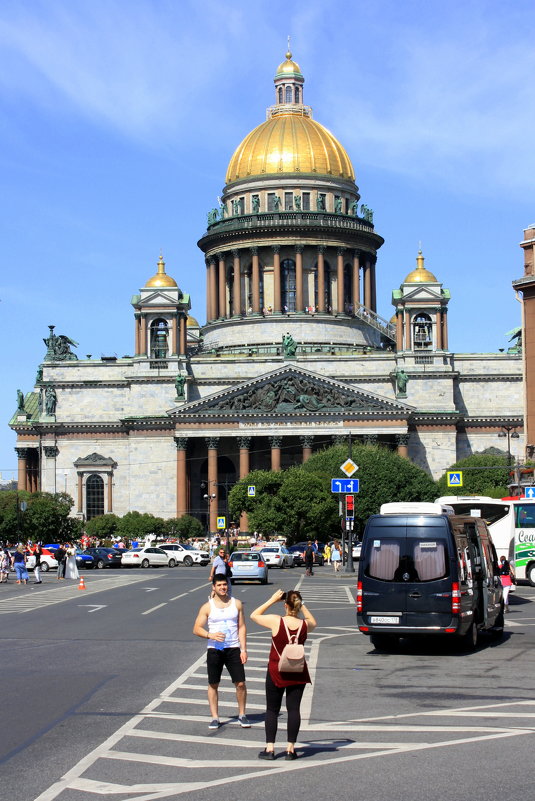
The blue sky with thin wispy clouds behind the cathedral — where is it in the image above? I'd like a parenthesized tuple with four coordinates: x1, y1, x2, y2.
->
(0, 0, 535, 478)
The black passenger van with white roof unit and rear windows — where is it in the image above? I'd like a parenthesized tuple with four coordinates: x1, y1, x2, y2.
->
(357, 503, 504, 649)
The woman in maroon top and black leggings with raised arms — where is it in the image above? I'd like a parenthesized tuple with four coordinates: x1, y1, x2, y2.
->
(251, 590, 316, 760)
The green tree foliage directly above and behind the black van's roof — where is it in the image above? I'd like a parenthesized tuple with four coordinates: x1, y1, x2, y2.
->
(437, 453, 509, 498)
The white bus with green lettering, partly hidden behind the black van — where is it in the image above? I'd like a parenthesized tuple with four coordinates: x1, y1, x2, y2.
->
(436, 495, 535, 587)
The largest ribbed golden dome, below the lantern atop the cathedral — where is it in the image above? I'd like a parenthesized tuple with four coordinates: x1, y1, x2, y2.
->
(226, 112, 355, 184)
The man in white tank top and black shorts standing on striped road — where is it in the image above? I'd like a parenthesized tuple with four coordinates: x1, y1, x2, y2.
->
(193, 573, 251, 729)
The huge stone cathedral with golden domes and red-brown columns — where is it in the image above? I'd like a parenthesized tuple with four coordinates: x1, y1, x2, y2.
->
(10, 52, 524, 531)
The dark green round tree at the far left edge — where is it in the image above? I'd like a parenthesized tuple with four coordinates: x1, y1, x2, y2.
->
(0, 492, 75, 542)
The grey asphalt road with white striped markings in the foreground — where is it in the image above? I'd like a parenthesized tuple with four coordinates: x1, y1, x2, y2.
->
(0, 567, 535, 801)
